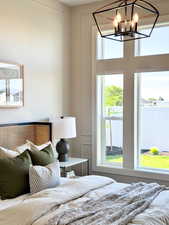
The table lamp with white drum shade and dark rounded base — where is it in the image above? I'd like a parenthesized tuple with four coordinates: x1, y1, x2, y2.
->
(53, 116, 76, 162)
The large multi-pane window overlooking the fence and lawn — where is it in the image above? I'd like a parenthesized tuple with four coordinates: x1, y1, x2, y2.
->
(93, 18, 169, 179)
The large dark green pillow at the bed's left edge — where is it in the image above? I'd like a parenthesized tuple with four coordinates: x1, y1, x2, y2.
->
(0, 151, 32, 200)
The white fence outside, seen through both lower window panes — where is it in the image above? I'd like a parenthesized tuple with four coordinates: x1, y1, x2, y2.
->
(106, 106, 169, 151)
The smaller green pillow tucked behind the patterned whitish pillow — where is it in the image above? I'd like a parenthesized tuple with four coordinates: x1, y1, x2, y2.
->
(29, 145, 56, 166)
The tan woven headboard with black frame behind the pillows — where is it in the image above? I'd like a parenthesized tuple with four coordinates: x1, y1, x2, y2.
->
(0, 122, 52, 149)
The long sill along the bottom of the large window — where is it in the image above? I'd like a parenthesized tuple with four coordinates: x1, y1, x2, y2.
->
(93, 164, 169, 181)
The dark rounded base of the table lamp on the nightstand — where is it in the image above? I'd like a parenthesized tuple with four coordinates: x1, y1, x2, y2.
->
(56, 139, 70, 162)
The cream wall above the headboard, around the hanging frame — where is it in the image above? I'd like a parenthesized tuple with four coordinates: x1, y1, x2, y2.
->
(0, 0, 71, 123)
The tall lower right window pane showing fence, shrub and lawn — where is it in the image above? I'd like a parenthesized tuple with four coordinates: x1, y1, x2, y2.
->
(137, 72, 169, 169)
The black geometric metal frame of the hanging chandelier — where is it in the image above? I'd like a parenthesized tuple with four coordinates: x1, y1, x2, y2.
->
(92, 0, 160, 42)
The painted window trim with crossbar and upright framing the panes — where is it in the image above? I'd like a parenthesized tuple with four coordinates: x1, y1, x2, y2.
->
(91, 15, 169, 181)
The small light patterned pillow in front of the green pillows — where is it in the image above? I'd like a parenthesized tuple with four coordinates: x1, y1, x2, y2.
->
(29, 161, 60, 194)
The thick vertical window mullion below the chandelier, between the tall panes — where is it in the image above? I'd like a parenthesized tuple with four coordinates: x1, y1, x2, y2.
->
(123, 41, 136, 169)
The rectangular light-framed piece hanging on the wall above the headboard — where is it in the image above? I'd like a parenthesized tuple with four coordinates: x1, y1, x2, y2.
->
(0, 62, 24, 108)
